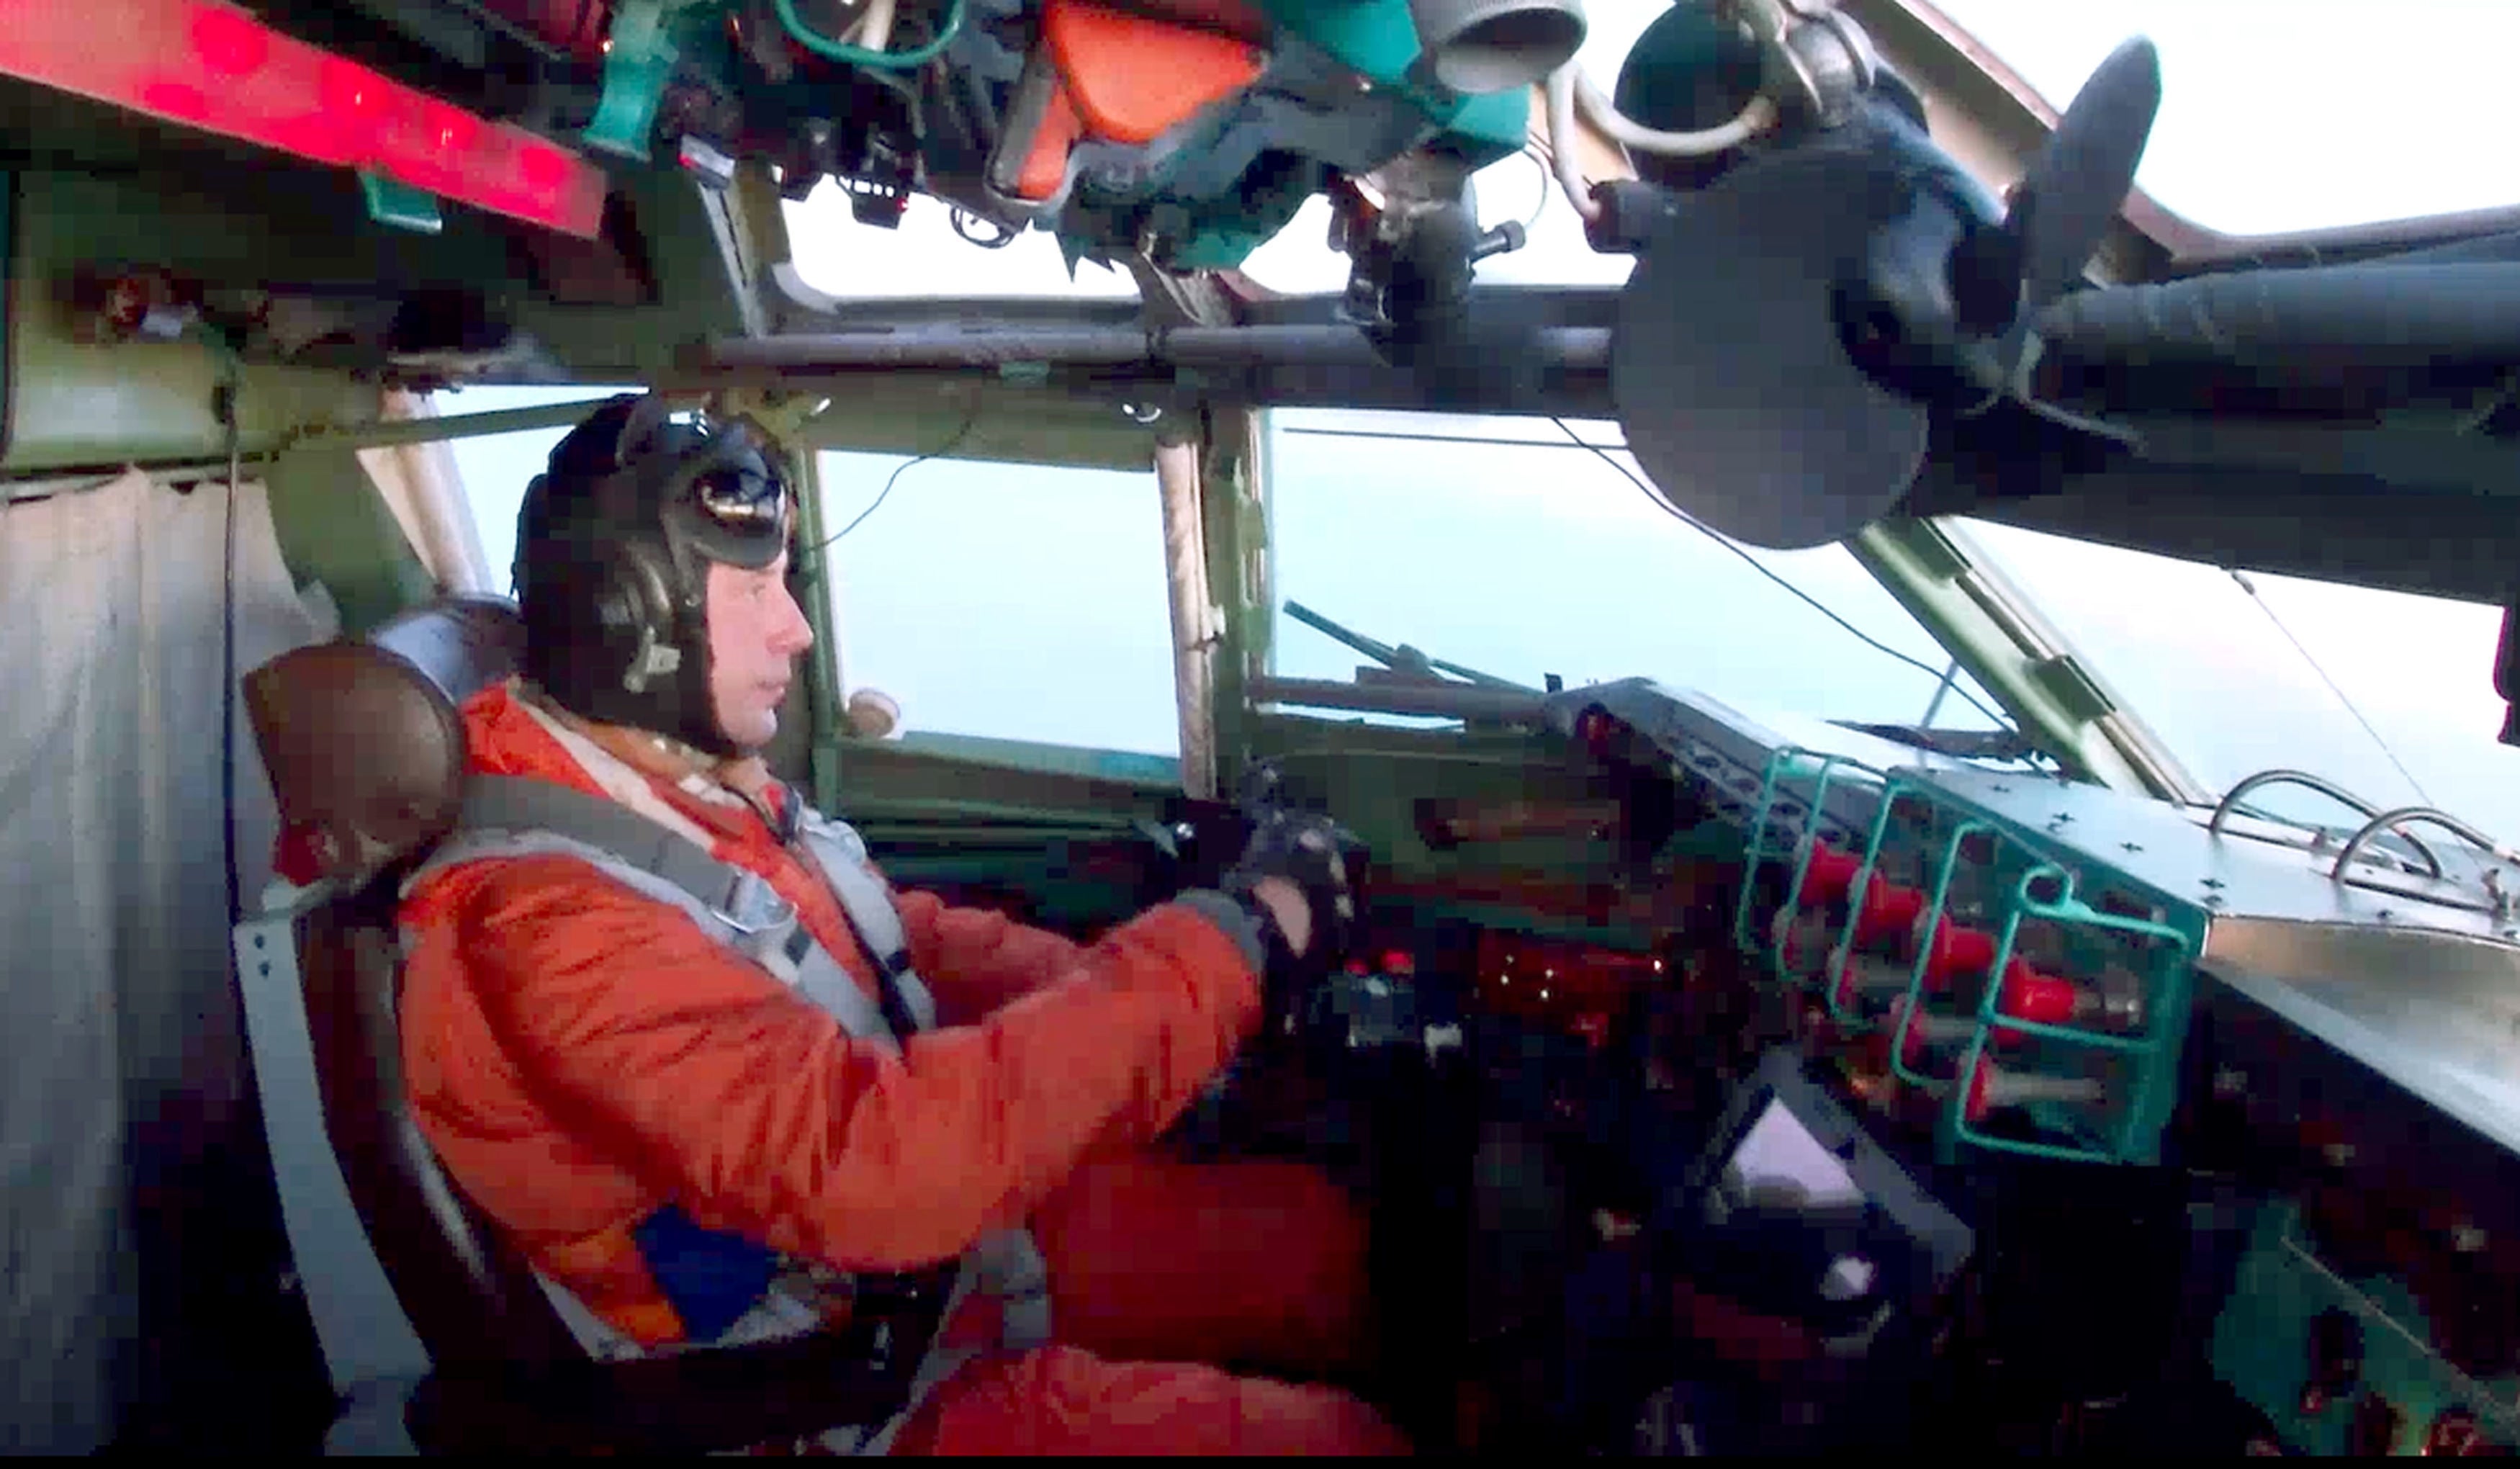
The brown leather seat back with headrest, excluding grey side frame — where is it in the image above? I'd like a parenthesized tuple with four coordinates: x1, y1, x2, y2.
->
(245, 597, 585, 1371)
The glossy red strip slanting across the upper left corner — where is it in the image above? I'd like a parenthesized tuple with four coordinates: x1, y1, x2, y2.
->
(0, 0, 605, 239)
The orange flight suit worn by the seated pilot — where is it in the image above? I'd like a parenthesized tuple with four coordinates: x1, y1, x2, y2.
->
(401, 688, 1406, 1454)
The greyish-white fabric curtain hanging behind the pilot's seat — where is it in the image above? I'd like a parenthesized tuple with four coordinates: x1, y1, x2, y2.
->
(0, 471, 320, 1454)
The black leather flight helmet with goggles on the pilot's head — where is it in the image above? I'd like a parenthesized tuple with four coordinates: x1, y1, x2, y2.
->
(517, 393, 796, 756)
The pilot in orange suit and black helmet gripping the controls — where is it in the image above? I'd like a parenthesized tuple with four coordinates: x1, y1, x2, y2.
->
(401, 395, 1406, 1454)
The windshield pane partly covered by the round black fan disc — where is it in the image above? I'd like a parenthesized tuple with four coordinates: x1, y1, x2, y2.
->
(1268, 410, 2001, 731)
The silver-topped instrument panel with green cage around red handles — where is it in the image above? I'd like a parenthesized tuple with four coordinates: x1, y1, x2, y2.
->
(1550, 680, 2520, 1454)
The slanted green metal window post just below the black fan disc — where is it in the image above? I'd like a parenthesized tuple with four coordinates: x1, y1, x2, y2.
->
(1845, 516, 2185, 799)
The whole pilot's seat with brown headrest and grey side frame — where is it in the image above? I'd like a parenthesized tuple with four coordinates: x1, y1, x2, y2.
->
(237, 597, 922, 1452)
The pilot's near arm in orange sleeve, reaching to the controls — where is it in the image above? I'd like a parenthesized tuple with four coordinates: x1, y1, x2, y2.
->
(413, 857, 1263, 1270)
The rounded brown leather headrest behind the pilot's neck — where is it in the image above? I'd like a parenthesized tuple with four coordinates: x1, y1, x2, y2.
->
(245, 597, 524, 882)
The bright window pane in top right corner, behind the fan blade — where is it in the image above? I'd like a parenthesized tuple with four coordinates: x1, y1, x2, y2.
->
(1935, 0, 2520, 234)
